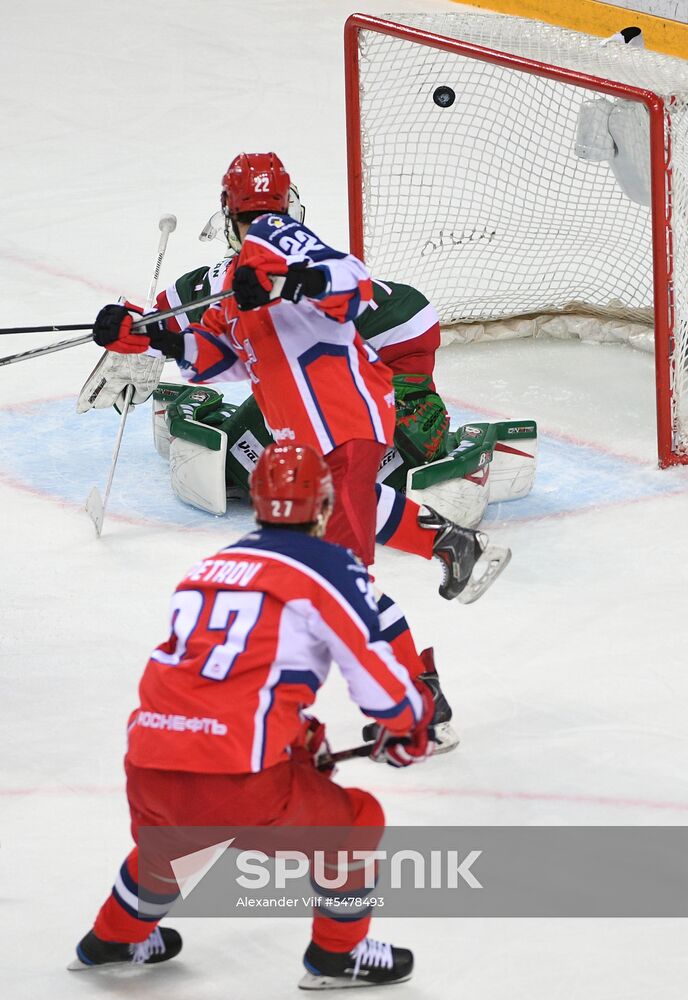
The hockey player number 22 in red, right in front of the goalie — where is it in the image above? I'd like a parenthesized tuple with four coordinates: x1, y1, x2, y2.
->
(94, 153, 506, 750)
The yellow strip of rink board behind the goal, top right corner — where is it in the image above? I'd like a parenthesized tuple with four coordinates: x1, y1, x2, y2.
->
(454, 0, 688, 59)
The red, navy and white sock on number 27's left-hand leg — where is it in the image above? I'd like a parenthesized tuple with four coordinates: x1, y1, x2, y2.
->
(93, 847, 178, 944)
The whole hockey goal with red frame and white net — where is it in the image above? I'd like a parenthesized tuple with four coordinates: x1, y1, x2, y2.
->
(345, 14, 688, 467)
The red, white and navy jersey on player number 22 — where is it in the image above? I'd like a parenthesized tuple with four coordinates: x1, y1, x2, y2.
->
(175, 215, 395, 454)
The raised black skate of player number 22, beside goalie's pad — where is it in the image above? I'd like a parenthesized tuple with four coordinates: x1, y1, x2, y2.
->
(418, 505, 511, 604)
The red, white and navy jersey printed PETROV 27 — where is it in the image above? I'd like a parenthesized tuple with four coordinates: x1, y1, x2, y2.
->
(127, 528, 422, 774)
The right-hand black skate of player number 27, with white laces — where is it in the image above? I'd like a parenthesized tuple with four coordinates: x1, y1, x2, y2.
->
(299, 938, 413, 990)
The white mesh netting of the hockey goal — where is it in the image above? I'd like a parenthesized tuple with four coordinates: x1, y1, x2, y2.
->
(359, 13, 688, 451)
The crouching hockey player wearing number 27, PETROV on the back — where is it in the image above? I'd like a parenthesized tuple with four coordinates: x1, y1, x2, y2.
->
(70, 444, 434, 989)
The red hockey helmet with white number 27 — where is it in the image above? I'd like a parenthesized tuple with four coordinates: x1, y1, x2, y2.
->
(251, 444, 334, 524)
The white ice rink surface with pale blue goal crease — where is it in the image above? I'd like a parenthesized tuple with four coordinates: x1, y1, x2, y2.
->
(0, 0, 688, 1000)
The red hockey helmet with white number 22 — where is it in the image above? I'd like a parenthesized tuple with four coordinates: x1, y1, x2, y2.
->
(220, 153, 289, 217)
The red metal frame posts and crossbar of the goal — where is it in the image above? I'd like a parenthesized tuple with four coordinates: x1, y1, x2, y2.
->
(344, 14, 676, 468)
